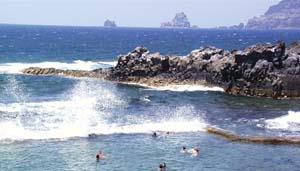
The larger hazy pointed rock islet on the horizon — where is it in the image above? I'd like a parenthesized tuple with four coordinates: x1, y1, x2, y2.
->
(161, 12, 191, 28)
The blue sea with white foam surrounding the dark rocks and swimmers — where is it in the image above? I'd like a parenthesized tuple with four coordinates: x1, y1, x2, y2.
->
(0, 25, 300, 171)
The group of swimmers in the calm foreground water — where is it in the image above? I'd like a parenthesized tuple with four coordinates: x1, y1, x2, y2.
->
(96, 132, 200, 171)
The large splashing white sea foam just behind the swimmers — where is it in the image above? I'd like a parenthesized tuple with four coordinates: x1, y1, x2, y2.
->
(0, 100, 206, 141)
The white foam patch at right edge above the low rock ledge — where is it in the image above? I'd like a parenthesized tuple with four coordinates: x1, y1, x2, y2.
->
(265, 111, 300, 131)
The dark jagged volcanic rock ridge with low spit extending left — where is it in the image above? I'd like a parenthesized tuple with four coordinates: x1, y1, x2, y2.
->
(23, 41, 300, 98)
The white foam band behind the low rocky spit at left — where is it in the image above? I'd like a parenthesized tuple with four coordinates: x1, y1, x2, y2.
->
(0, 60, 117, 74)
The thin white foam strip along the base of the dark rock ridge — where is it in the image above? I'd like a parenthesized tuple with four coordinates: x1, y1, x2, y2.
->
(123, 83, 224, 92)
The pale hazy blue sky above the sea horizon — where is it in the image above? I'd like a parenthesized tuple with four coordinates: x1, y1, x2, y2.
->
(0, 0, 280, 28)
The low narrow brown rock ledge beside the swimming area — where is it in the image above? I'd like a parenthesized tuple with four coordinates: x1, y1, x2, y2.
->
(206, 127, 300, 145)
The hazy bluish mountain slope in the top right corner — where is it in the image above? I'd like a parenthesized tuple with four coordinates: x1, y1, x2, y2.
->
(246, 0, 300, 29)
